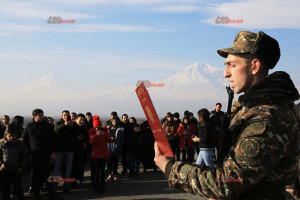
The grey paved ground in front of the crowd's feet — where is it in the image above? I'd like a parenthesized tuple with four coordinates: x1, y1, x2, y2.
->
(24, 169, 205, 200)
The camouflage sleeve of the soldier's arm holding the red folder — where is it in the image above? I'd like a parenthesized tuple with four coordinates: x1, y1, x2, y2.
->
(166, 121, 286, 199)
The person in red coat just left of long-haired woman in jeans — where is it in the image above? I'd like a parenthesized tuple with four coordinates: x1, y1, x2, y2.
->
(176, 116, 196, 163)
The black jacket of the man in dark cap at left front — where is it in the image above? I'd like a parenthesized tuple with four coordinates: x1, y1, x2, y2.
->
(22, 121, 56, 161)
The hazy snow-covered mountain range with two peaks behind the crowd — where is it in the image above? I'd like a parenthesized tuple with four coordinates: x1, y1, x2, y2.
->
(0, 63, 231, 116)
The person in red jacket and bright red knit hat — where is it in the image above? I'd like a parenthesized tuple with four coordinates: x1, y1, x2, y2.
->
(89, 126, 112, 194)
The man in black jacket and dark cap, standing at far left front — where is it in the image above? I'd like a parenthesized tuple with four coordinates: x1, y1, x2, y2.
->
(22, 109, 59, 200)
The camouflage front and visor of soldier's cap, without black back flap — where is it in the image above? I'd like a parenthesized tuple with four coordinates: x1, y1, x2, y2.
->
(217, 31, 260, 58)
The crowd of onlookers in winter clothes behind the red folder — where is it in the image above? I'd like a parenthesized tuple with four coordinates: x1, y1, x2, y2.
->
(0, 103, 224, 200)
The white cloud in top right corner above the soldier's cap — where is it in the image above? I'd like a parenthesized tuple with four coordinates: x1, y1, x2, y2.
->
(202, 0, 300, 29)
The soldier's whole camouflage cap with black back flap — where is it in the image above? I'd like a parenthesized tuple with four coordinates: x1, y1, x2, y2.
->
(217, 31, 280, 69)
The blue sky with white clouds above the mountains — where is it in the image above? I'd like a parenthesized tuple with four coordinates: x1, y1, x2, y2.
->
(0, 0, 300, 90)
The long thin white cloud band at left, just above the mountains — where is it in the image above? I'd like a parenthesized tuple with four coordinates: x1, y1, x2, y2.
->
(0, 49, 184, 72)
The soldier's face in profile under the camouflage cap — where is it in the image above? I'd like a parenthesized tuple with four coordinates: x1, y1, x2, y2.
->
(224, 54, 254, 94)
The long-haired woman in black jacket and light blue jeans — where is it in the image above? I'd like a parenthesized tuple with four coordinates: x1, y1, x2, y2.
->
(193, 108, 216, 167)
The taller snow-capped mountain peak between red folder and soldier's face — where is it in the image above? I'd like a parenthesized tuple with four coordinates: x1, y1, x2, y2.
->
(149, 63, 229, 100)
